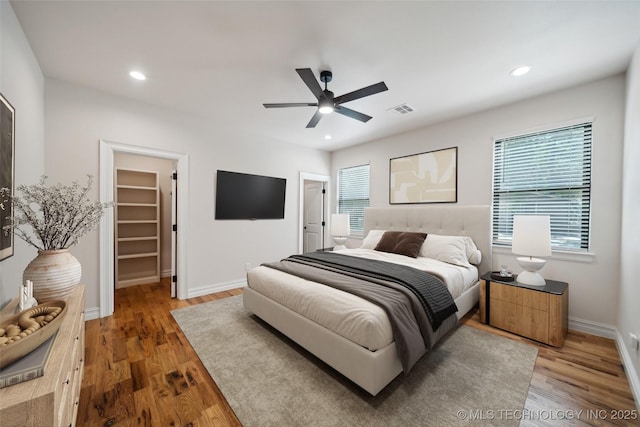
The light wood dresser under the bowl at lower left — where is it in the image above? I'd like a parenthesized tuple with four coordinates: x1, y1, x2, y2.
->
(0, 285, 85, 427)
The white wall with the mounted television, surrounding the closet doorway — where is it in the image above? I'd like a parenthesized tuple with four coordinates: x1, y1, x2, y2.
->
(45, 79, 330, 310)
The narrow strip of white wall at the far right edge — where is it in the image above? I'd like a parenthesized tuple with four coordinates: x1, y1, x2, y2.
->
(618, 45, 640, 398)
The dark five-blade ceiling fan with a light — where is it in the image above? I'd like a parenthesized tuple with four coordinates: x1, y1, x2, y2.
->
(263, 68, 388, 128)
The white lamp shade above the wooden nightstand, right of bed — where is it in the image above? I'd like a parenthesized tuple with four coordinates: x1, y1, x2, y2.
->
(511, 215, 551, 257)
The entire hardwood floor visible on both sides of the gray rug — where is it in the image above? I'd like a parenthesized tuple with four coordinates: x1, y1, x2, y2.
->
(78, 281, 640, 426)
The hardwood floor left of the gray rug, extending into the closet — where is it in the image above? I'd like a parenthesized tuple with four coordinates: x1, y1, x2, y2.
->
(77, 281, 242, 426)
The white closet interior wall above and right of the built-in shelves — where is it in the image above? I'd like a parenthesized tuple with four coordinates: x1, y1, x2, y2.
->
(113, 153, 176, 277)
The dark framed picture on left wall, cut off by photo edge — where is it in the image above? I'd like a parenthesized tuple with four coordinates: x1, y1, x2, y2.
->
(0, 93, 16, 261)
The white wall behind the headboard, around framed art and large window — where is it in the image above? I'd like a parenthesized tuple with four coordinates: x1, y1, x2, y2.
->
(331, 75, 625, 331)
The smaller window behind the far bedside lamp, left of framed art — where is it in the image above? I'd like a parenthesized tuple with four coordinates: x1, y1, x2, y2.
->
(338, 165, 369, 235)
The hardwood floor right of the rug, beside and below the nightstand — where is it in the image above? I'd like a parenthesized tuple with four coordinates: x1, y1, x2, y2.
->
(462, 309, 640, 426)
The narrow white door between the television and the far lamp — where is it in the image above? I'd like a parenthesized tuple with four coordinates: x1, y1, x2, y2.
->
(303, 181, 324, 252)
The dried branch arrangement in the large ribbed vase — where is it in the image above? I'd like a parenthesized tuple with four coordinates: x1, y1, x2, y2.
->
(0, 175, 113, 250)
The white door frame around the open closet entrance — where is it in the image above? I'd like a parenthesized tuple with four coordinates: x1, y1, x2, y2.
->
(100, 140, 189, 317)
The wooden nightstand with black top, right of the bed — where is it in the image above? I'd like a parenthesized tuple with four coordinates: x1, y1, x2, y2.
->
(480, 273, 569, 347)
